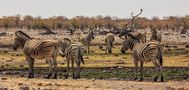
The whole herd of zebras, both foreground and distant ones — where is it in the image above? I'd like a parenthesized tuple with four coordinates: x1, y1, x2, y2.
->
(13, 29, 163, 81)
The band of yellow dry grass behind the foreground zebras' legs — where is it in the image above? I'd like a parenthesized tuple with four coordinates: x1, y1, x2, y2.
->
(0, 46, 189, 67)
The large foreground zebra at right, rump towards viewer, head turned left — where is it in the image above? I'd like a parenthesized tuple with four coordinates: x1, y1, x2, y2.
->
(124, 33, 163, 81)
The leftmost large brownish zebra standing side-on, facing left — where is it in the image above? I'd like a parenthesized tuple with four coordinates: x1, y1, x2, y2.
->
(13, 31, 58, 78)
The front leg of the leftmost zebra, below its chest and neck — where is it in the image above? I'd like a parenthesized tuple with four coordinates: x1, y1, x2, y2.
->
(26, 56, 34, 78)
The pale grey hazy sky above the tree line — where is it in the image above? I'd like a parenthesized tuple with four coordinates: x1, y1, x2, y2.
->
(0, 0, 189, 18)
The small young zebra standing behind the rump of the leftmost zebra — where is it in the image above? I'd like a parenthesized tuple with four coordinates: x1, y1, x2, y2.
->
(59, 38, 85, 79)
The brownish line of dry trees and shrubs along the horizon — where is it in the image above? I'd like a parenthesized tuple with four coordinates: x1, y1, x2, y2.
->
(0, 14, 189, 33)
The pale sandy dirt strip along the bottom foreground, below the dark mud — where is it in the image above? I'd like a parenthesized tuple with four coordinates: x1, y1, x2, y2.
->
(0, 76, 189, 90)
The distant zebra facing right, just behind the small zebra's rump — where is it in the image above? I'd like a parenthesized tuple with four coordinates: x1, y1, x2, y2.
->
(80, 30, 94, 53)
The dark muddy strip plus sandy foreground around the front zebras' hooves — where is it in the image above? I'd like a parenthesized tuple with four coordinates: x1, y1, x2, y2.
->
(0, 67, 189, 90)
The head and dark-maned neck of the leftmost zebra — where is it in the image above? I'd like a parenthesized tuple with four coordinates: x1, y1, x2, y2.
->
(13, 31, 32, 51)
